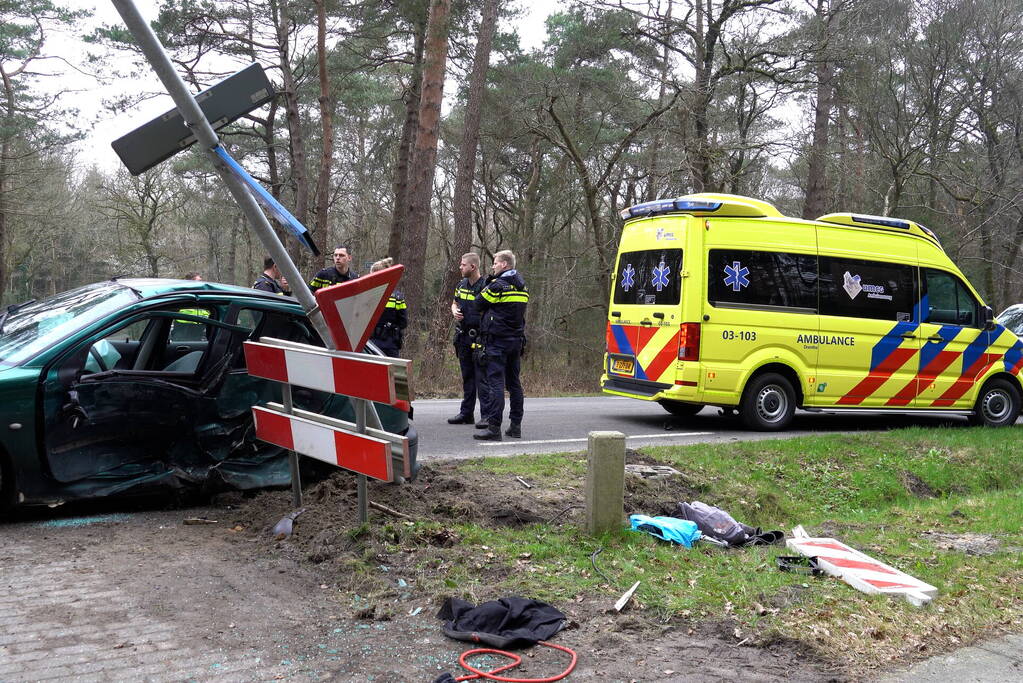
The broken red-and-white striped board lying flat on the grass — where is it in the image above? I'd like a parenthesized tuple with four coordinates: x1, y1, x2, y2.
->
(786, 527, 938, 607)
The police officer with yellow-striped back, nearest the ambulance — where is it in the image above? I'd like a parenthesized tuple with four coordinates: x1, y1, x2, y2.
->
(473, 251, 529, 441)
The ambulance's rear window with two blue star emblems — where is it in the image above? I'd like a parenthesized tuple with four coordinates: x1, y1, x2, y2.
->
(614, 249, 682, 306)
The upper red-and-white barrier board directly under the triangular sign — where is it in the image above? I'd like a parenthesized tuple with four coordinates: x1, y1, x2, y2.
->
(244, 340, 411, 405)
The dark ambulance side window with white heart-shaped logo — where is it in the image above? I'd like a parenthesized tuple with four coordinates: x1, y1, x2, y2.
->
(820, 257, 919, 322)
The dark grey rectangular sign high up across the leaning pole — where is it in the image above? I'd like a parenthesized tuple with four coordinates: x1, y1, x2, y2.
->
(110, 63, 274, 176)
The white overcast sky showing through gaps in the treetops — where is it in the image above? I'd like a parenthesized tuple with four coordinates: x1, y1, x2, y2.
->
(71, 0, 561, 170)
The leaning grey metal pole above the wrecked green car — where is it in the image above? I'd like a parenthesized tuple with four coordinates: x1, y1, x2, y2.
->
(110, 0, 336, 349)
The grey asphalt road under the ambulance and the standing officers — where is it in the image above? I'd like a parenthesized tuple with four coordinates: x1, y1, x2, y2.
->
(415, 396, 966, 461)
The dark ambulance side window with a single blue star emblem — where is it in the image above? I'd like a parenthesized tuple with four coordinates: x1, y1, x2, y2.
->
(707, 249, 817, 313)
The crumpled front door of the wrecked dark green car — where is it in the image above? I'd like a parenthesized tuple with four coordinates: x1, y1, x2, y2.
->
(43, 308, 251, 482)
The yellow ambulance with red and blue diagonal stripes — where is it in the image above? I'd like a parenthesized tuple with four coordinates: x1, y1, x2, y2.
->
(601, 193, 1023, 430)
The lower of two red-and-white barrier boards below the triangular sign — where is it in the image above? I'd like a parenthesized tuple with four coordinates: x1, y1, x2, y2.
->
(253, 407, 394, 482)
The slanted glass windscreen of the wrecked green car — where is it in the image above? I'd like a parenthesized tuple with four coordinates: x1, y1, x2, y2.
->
(0, 282, 138, 367)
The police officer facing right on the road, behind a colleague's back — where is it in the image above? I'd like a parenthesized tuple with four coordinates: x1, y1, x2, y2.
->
(448, 253, 488, 429)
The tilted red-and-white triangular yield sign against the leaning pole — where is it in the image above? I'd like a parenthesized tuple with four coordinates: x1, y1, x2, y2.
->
(316, 265, 405, 351)
